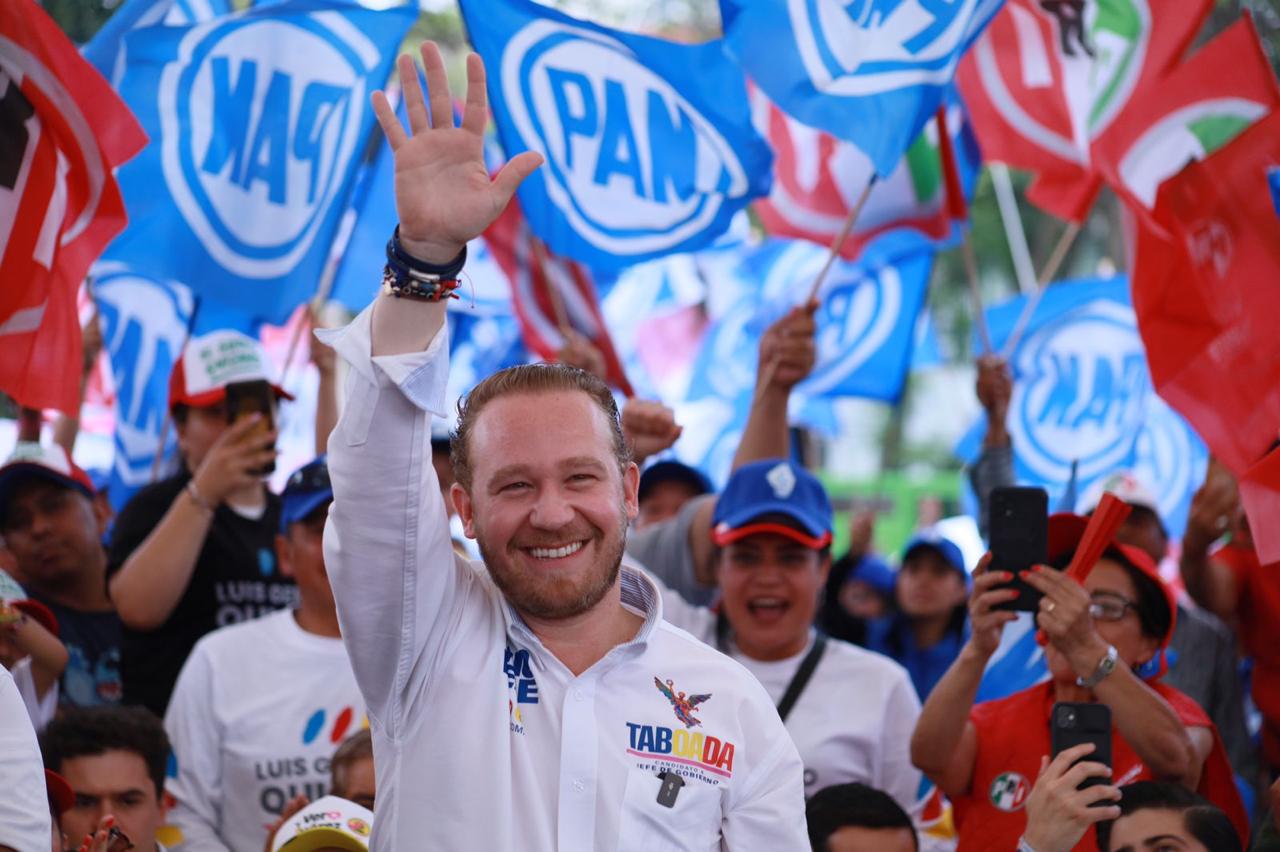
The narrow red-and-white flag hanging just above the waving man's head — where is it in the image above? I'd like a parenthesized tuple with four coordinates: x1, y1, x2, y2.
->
(484, 198, 635, 397)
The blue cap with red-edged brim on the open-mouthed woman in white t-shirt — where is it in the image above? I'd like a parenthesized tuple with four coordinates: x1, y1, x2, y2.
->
(712, 458, 832, 550)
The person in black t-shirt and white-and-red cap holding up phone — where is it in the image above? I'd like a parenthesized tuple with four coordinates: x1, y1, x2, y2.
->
(108, 331, 297, 716)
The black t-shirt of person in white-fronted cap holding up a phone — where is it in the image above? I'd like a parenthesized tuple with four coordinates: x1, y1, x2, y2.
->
(106, 471, 298, 716)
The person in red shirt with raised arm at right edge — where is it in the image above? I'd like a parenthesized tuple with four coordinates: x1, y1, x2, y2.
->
(1180, 459, 1280, 778)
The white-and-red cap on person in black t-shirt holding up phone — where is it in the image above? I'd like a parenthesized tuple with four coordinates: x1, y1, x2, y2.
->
(169, 329, 293, 408)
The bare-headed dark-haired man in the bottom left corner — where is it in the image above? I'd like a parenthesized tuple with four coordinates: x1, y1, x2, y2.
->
(40, 706, 169, 852)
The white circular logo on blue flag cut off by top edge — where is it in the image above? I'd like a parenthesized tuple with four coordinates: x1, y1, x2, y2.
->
(787, 0, 998, 97)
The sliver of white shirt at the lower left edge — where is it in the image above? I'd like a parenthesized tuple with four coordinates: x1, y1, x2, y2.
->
(0, 665, 54, 852)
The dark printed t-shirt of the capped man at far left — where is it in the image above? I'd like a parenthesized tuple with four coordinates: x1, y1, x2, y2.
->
(31, 592, 122, 707)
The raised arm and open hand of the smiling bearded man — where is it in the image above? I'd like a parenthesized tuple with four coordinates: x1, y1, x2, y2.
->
(324, 42, 539, 738)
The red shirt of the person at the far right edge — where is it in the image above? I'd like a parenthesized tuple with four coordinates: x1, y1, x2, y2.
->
(1212, 545, 1280, 766)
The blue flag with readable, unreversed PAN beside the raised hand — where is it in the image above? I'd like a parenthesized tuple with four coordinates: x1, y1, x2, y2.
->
(462, 0, 773, 271)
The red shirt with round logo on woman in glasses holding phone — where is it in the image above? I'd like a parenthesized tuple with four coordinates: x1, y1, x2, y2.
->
(951, 682, 1249, 852)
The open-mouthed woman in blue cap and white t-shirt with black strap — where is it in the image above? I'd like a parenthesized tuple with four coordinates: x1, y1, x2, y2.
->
(645, 459, 920, 810)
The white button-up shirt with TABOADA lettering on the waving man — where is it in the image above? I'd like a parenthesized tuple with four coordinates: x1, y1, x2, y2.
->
(316, 306, 809, 852)
